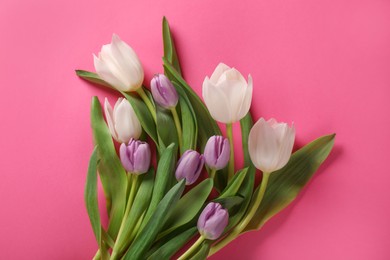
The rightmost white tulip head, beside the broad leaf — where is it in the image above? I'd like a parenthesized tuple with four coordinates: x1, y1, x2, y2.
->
(248, 118, 295, 173)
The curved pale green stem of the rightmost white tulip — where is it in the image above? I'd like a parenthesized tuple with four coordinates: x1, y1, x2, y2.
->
(209, 173, 270, 256)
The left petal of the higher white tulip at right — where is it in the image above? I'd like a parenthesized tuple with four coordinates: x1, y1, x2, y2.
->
(202, 77, 232, 124)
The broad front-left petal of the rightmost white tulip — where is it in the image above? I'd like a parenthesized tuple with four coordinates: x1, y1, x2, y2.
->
(248, 118, 279, 172)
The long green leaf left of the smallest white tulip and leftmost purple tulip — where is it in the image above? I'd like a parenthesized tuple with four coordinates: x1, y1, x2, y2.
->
(91, 97, 127, 239)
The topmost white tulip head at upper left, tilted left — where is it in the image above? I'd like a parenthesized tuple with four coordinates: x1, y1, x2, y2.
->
(94, 34, 144, 92)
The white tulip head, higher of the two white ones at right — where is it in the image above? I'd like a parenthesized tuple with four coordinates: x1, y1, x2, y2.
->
(203, 63, 253, 124)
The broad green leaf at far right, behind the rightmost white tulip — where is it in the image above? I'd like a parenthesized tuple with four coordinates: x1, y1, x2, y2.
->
(244, 134, 335, 232)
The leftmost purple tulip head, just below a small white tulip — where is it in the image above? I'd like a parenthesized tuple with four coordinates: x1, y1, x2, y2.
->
(119, 139, 151, 174)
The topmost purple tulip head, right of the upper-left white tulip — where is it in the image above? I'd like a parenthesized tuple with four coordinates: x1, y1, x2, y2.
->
(150, 74, 179, 109)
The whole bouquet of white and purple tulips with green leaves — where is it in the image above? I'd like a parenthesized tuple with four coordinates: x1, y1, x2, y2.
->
(76, 18, 334, 260)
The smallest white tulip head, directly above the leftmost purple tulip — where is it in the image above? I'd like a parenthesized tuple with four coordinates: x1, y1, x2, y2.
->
(104, 98, 142, 143)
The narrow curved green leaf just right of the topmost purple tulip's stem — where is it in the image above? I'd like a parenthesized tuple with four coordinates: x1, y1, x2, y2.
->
(172, 82, 198, 153)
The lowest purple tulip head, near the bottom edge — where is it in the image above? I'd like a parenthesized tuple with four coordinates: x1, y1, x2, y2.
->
(198, 202, 229, 240)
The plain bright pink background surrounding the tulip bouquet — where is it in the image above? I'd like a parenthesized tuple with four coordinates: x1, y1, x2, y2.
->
(0, 0, 390, 260)
